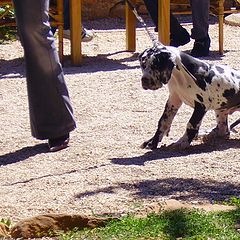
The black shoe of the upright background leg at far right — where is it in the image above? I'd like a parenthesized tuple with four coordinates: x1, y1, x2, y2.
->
(191, 36, 211, 57)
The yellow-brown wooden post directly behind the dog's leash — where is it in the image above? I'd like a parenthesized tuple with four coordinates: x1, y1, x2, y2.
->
(125, 0, 136, 52)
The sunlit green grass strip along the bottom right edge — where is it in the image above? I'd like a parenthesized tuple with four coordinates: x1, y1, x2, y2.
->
(59, 206, 240, 240)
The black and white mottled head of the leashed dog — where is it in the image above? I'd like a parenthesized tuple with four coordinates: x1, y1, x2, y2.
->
(138, 45, 175, 90)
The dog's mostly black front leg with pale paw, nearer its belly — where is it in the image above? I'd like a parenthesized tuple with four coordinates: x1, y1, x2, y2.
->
(171, 101, 206, 149)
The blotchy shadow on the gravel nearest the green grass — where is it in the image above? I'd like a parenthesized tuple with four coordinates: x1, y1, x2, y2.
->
(75, 178, 240, 202)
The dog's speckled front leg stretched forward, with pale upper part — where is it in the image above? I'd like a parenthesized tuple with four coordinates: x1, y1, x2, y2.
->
(141, 96, 182, 150)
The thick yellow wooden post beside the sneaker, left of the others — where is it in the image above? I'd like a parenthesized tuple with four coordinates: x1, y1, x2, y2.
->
(70, 0, 82, 66)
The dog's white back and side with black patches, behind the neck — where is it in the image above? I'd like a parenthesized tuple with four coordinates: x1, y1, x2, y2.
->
(180, 52, 240, 111)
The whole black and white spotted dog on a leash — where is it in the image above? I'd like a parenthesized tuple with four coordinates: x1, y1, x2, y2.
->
(139, 44, 240, 149)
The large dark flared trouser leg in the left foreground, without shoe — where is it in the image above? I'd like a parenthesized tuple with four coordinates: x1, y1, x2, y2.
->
(14, 0, 76, 146)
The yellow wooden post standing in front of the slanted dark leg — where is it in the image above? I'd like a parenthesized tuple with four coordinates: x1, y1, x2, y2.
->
(158, 0, 170, 45)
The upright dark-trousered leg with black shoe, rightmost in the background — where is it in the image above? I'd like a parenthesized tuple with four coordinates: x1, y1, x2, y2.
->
(190, 0, 210, 57)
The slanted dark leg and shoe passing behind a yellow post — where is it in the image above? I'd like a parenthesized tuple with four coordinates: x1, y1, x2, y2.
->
(144, 0, 190, 47)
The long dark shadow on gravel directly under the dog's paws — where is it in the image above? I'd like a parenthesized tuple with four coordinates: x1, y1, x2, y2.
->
(111, 139, 239, 166)
